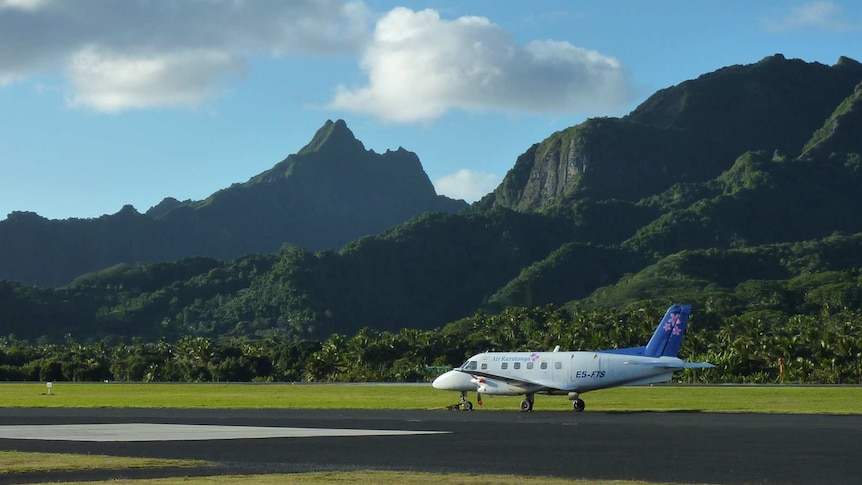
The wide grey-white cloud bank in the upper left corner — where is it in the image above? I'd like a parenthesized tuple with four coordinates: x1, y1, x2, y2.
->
(0, 0, 370, 111)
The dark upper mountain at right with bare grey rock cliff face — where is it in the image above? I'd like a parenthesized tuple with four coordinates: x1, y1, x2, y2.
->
(486, 54, 862, 211)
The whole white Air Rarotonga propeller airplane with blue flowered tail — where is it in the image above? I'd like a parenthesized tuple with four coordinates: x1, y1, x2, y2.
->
(431, 304, 715, 412)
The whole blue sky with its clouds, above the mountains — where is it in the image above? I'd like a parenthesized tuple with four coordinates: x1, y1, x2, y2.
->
(0, 0, 862, 219)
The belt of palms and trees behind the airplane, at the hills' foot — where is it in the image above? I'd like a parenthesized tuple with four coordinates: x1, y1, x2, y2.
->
(0, 302, 862, 384)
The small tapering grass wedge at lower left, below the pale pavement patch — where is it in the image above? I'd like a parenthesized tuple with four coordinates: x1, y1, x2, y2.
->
(0, 451, 208, 475)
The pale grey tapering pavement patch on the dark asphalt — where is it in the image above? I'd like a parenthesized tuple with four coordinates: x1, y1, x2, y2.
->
(0, 423, 448, 441)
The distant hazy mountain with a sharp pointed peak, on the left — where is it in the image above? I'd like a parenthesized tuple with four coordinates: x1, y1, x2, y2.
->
(0, 120, 468, 286)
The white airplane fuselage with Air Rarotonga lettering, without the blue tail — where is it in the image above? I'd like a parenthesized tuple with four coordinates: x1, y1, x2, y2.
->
(433, 352, 685, 395)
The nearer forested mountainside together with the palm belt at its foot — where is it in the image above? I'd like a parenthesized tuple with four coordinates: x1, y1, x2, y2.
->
(0, 55, 862, 382)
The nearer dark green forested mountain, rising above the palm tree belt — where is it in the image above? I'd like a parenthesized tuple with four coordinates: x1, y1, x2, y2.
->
(0, 56, 862, 346)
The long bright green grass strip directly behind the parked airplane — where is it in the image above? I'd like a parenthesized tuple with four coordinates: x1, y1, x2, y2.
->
(0, 382, 862, 414)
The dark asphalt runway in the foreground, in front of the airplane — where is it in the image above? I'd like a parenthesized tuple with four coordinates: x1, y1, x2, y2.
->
(0, 408, 862, 484)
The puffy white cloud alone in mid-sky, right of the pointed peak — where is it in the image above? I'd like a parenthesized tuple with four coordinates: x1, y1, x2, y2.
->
(329, 8, 634, 122)
